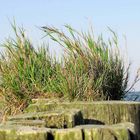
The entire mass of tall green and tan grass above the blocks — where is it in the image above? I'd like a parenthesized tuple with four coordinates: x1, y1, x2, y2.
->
(0, 25, 138, 114)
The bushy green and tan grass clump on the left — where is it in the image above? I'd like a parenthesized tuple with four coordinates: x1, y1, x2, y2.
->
(0, 25, 59, 114)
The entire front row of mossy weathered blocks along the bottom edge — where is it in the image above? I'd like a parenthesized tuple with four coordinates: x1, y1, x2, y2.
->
(0, 123, 136, 140)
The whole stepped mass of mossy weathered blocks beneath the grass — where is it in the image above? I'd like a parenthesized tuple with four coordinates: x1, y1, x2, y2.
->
(0, 99, 140, 140)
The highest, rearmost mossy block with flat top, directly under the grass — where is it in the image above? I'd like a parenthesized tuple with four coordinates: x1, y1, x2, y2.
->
(25, 99, 140, 139)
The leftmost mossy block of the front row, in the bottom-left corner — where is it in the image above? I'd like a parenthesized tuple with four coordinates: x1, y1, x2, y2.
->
(0, 125, 50, 140)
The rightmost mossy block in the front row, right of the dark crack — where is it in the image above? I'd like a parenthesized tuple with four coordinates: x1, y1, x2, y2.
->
(76, 123, 136, 140)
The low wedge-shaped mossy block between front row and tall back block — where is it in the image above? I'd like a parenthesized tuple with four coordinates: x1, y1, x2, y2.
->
(7, 109, 83, 128)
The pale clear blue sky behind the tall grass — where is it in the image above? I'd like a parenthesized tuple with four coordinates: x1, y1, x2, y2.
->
(0, 0, 140, 91)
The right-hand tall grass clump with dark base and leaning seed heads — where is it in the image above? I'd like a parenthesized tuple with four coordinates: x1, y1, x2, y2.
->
(42, 25, 129, 100)
